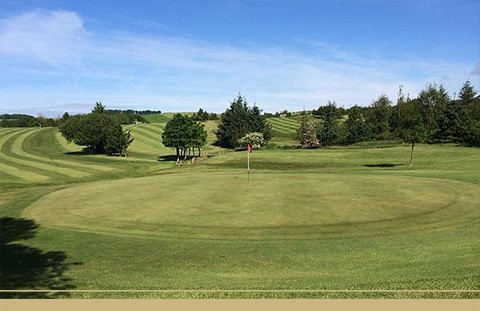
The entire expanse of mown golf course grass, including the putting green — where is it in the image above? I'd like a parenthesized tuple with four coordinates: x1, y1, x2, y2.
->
(0, 120, 480, 298)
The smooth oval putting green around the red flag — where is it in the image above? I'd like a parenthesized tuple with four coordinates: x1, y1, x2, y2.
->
(24, 172, 480, 239)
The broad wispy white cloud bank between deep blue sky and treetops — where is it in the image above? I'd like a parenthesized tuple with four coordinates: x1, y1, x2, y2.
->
(0, 11, 478, 117)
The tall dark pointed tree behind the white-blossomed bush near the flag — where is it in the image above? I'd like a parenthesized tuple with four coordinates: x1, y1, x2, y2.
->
(216, 95, 272, 148)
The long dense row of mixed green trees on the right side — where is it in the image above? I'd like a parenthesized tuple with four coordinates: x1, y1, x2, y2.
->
(299, 81, 480, 147)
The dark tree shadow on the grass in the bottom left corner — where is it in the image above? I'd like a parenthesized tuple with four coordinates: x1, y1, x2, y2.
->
(0, 217, 81, 298)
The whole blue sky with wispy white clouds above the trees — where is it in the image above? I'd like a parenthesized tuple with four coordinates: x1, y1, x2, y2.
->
(0, 0, 480, 117)
